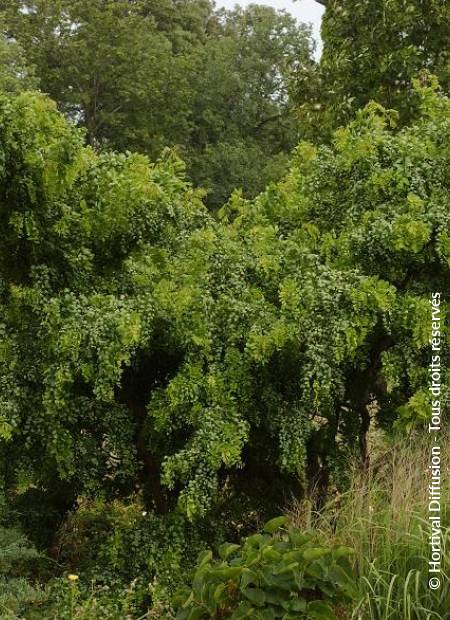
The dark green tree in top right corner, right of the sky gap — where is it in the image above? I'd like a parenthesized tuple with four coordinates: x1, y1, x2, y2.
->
(298, 0, 450, 139)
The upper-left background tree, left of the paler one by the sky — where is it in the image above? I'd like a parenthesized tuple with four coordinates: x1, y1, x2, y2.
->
(0, 0, 203, 158)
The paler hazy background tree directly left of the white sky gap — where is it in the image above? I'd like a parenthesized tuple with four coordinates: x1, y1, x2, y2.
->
(186, 5, 313, 207)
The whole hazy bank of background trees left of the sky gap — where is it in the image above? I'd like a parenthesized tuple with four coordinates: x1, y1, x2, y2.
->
(3, 0, 313, 207)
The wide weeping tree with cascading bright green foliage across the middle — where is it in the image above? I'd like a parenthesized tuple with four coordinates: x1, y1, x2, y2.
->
(0, 87, 450, 532)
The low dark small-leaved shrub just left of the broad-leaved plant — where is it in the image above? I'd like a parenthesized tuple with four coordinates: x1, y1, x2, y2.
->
(57, 500, 212, 610)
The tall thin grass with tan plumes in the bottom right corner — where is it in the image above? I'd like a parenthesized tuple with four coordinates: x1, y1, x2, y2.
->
(292, 433, 450, 620)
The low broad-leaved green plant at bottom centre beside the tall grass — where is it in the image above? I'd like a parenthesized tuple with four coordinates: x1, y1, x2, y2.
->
(176, 517, 357, 620)
